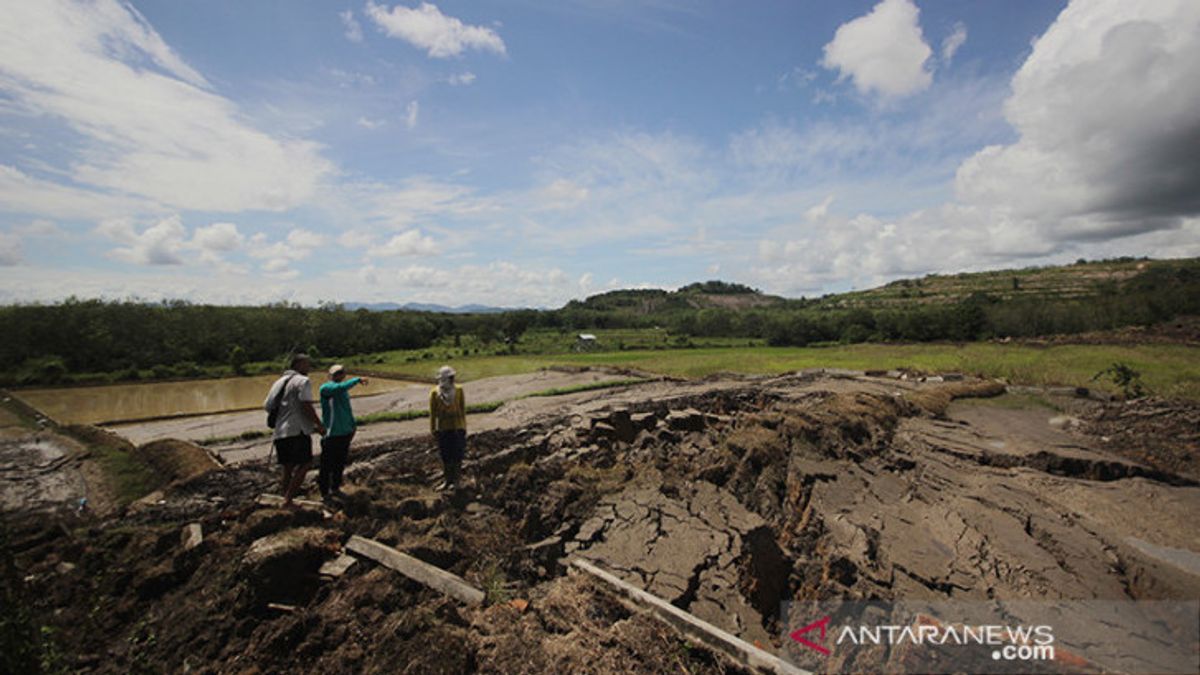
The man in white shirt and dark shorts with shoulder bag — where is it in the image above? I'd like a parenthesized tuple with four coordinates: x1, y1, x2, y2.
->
(263, 354, 325, 507)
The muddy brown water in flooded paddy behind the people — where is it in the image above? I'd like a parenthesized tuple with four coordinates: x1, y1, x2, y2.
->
(16, 374, 416, 424)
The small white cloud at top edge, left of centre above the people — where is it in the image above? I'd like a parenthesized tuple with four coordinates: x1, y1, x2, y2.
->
(366, 0, 505, 59)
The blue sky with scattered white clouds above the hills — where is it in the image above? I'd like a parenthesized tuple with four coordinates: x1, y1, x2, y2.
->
(0, 0, 1200, 307)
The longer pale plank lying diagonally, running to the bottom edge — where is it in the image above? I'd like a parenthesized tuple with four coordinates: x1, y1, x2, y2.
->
(570, 558, 812, 675)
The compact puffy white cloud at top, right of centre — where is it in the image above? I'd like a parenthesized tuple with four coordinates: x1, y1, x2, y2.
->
(821, 0, 934, 97)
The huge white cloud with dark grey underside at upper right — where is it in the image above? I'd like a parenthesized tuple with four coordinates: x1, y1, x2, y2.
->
(955, 0, 1200, 241)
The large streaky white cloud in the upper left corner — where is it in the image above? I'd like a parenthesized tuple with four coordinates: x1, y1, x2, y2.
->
(0, 0, 331, 211)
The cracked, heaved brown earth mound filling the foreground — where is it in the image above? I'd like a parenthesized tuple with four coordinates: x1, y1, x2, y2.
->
(6, 377, 1200, 673)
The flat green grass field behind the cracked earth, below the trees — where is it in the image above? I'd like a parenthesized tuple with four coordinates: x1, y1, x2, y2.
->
(360, 342, 1200, 400)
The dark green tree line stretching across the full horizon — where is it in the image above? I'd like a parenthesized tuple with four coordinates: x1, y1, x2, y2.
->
(0, 258, 1200, 384)
